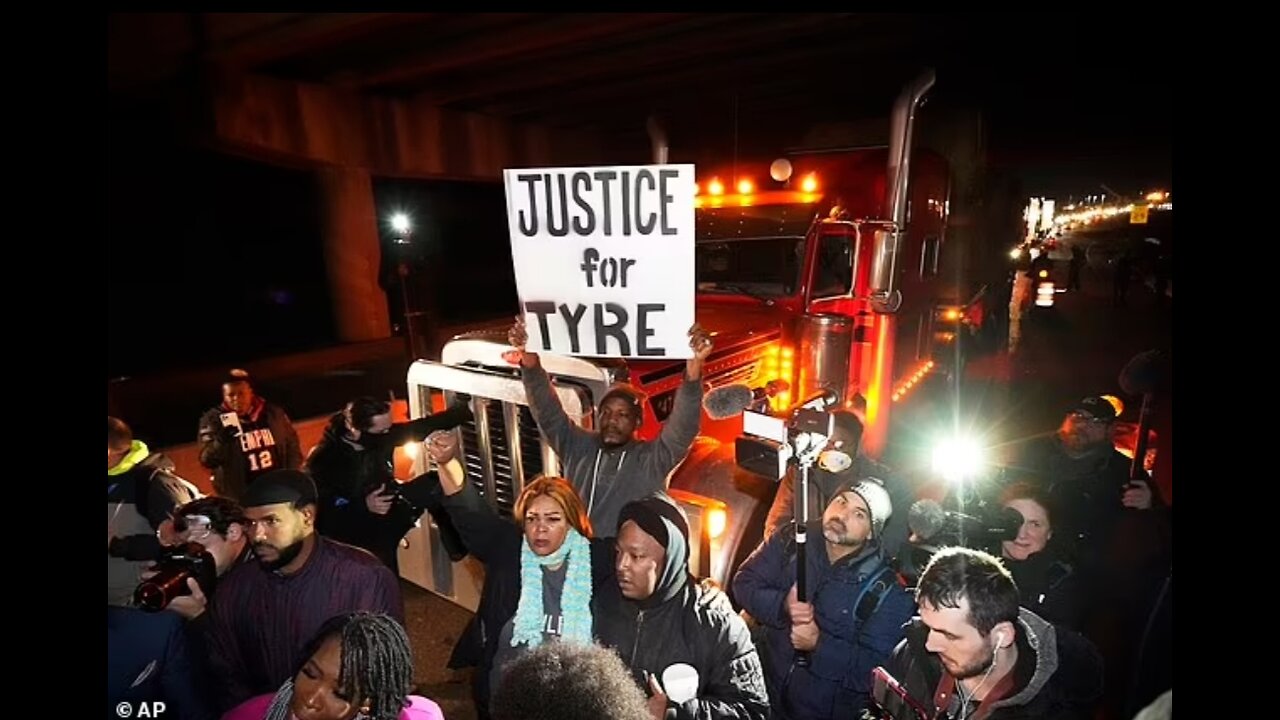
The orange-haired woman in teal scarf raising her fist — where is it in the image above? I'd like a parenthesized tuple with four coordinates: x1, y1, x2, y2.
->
(426, 432, 616, 717)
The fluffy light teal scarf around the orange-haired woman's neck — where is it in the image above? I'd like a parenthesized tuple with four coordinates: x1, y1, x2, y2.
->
(511, 528, 591, 647)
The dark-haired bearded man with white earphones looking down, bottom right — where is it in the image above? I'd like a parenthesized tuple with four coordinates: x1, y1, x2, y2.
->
(877, 547, 1102, 720)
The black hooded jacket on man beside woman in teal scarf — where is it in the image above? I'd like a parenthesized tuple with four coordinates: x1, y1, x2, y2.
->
(595, 495, 769, 720)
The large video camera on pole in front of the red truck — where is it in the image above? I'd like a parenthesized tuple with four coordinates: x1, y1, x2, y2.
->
(733, 391, 840, 482)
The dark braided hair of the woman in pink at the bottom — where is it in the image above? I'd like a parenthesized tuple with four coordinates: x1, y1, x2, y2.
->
(303, 612, 413, 720)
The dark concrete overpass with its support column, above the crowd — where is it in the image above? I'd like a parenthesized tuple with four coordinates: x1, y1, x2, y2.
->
(108, 13, 1000, 437)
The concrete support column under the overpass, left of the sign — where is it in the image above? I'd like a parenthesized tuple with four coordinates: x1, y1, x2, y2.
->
(316, 165, 392, 342)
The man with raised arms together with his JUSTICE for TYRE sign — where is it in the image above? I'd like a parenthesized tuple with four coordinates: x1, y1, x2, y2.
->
(503, 165, 712, 529)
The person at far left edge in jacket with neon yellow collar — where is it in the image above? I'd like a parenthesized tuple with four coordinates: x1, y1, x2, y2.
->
(106, 416, 197, 606)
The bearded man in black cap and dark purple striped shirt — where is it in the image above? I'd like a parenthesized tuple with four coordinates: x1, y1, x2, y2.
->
(209, 470, 404, 711)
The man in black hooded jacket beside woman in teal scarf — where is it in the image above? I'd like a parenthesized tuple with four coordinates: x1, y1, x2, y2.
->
(595, 493, 769, 720)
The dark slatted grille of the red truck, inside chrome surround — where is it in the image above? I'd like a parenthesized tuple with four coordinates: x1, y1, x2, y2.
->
(460, 397, 543, 516)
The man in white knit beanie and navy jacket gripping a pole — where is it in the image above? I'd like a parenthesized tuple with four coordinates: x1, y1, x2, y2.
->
(733, 478, 915, 720)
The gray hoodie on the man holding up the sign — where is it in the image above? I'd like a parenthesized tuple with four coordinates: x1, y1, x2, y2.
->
(521, 365, 703, 533)
